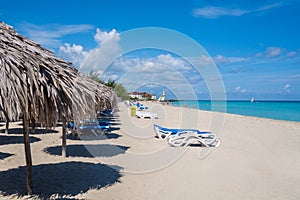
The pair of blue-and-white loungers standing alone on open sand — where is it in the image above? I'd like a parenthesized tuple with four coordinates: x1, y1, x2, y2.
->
(153, 124, 220, 147)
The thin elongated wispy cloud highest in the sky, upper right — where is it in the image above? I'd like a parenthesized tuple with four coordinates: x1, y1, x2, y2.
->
(192, 3, 281, 19)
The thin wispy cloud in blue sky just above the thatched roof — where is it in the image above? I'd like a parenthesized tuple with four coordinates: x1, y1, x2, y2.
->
(20, 23, 94, 48)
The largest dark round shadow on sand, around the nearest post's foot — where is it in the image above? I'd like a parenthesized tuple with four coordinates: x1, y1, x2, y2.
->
(0, 162, 121, 199)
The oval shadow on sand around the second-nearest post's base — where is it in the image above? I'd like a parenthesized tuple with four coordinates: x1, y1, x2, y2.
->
(43, 144, 129, 158)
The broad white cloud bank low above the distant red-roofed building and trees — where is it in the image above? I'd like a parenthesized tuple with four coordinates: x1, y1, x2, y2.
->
(108, 54, 202, 98)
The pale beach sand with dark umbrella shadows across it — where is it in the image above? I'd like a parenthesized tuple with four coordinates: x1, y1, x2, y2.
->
(0, 102, 300, 200)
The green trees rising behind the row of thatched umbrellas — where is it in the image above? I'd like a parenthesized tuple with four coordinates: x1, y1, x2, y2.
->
(88, 70, 130, 100)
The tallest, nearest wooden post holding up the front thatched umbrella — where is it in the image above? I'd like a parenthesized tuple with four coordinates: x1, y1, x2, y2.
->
(23, 116, 32, 195)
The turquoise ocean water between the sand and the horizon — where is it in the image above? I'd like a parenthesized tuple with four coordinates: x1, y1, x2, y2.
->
(172, 100, 300, 122)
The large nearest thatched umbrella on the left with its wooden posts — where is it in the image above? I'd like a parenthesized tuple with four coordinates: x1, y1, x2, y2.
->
(0, 22, 113, 194)
